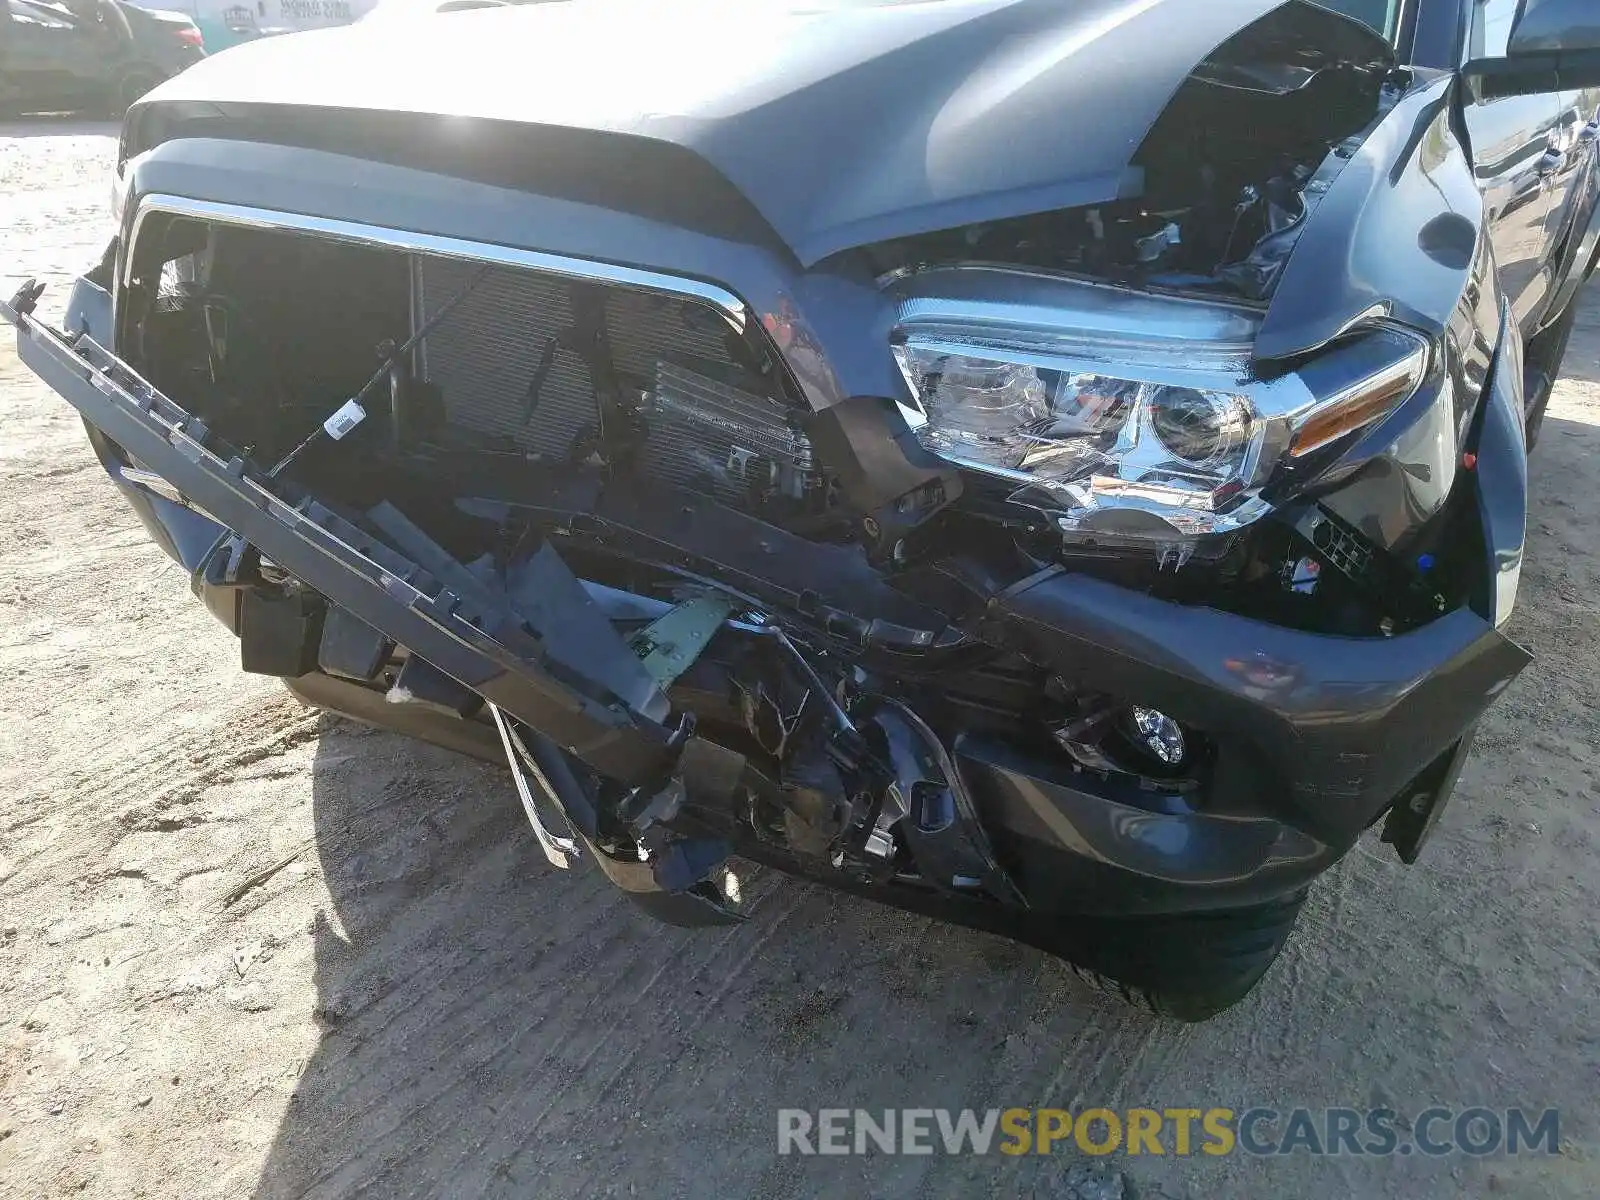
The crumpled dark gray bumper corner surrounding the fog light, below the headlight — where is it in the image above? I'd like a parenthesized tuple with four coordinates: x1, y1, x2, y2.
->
(957, 568, 1530, 912)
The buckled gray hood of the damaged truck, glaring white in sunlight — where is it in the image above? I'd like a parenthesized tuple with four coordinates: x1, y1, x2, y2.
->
(140, 0, 1376, 266)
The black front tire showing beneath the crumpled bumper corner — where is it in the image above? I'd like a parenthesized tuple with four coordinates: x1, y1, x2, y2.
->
(1051, 893, 1306, 1021)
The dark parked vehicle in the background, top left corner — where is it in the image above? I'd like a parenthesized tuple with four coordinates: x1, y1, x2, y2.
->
(0, 0, 205, 117)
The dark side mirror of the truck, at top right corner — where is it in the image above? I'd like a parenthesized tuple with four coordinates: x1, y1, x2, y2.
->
(1462, 0, 1600, 99)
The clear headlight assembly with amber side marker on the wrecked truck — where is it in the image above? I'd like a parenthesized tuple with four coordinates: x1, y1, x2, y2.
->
(893, 267, 1429, 542)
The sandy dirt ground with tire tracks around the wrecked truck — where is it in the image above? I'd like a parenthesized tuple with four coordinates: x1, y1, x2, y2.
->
(0, 123, 1600, 1200)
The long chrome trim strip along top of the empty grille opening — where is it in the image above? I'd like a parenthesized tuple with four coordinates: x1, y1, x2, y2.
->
(123, 192, 747, 330)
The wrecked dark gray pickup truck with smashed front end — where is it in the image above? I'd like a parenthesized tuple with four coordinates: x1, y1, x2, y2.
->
(0, 0, 1600, 1019)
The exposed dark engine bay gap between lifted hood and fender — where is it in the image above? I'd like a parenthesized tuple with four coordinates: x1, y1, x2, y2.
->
(861, 10, 1406, 301)
